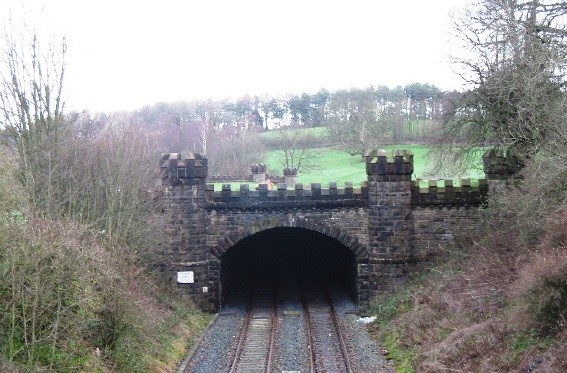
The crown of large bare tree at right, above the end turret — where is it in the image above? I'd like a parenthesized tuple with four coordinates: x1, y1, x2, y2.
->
(443, 0, 567, 159)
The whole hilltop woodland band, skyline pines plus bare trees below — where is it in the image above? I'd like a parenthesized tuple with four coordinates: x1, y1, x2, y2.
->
(67, 83, 454, 175)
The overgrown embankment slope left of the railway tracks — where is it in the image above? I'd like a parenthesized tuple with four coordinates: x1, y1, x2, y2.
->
(0, 146, 211, 373)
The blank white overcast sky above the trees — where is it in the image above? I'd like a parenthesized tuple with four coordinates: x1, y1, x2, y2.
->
(0, 0, 465, 111)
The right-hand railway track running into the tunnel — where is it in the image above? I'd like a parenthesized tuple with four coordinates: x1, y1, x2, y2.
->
(302, 282, 353, 373)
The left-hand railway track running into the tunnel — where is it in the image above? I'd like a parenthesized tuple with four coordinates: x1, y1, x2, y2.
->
(230, 282, 278, 373)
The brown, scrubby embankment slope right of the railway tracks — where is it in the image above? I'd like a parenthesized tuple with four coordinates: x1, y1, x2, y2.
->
(370, 219, 567, 373)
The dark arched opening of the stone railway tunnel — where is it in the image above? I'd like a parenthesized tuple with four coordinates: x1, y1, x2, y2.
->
(220, 227, 357, 306)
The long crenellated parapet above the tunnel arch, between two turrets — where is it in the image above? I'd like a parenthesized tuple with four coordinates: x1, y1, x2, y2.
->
(205, 182, 368, 209)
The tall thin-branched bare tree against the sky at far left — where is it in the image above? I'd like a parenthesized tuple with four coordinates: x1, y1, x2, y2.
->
(0, 18, 67, 215)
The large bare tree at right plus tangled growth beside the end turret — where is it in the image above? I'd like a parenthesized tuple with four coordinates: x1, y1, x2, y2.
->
(439, 0, 567, 241)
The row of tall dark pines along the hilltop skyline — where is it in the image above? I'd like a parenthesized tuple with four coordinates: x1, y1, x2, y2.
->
(126, 83, 446, 134)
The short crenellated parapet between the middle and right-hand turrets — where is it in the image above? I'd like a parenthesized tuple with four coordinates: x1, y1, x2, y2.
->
(411, 179, 488, 206)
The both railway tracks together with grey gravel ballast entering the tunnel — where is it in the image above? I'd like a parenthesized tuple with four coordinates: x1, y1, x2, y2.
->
(185, 278, 360, 373)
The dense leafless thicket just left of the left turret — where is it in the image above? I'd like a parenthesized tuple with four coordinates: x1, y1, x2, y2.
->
(62, 119, 157, 244)
